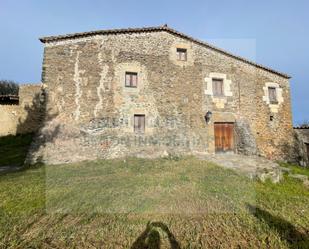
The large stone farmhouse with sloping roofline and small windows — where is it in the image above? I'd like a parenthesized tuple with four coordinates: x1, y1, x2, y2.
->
(25, 25, 293, 163)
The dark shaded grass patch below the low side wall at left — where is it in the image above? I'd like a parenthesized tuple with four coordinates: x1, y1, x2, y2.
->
(0, 133, 33, 167)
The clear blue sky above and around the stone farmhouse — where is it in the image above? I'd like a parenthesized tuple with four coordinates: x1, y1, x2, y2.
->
(0, 0, 309, 123)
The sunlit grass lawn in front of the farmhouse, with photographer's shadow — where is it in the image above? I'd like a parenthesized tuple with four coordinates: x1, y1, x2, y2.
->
(0, 157, 309, 248)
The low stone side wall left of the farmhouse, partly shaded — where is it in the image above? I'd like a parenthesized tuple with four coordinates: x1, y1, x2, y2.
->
(0, 84, 42, 136)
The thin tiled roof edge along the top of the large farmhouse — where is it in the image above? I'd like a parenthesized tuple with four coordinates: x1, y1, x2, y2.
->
(39, 25, 291, 79)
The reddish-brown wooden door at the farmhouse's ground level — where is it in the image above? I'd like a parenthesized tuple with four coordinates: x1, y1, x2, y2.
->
(214, 123, 234, 152)
